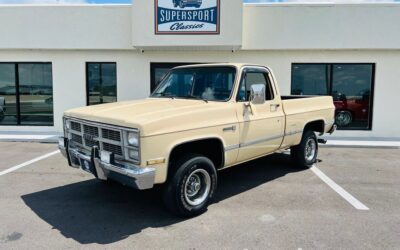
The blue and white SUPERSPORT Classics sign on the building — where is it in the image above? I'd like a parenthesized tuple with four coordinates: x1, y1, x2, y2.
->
(154, 0, 220, 35)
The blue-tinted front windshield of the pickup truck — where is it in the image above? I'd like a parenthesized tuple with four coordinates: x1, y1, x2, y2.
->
(151, 67, 236, 101)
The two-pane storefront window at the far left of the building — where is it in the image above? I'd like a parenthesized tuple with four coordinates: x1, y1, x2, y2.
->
(0, 63, 53, 126)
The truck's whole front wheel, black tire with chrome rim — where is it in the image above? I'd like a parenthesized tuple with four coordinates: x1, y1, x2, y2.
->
(163, 154, 217, 217)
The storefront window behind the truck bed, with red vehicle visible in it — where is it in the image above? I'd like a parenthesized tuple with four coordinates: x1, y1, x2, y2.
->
(292, 64, 375, 130)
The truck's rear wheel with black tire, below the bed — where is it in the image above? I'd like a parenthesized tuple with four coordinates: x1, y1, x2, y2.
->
(290, 130, 318, 168)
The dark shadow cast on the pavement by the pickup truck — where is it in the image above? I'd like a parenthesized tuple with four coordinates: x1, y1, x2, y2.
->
(22, 154, 304, 244)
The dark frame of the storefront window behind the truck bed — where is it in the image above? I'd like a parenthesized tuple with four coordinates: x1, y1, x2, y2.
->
(290, 62, 376, 131)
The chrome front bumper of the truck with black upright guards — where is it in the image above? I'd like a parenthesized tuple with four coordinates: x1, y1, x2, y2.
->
(58, 137, 156, 190)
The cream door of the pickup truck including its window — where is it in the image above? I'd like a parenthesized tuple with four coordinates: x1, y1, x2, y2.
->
(236, 67, 285, 161)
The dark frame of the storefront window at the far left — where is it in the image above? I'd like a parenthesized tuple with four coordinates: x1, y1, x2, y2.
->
(0, 61, 54, 127)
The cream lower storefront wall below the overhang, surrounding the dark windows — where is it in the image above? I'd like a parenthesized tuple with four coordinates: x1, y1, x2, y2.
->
(0, 50, 400, 138)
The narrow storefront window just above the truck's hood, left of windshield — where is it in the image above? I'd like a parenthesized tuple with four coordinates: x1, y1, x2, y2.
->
(86, 63, 117, 105)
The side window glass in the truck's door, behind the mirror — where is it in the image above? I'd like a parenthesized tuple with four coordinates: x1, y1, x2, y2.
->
(237, 72, 274, 102)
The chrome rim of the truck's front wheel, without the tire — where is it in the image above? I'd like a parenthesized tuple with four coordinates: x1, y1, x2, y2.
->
(184, 169, 211, 206)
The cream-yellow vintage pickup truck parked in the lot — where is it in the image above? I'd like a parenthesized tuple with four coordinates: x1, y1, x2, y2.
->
(59, 64, 336, 217)
